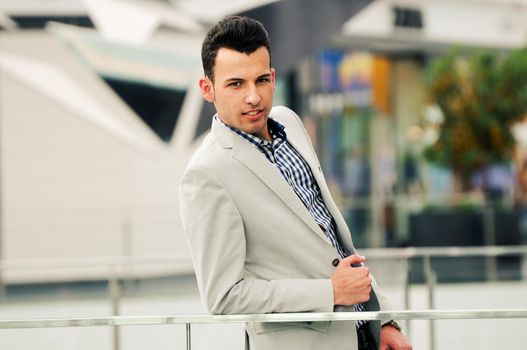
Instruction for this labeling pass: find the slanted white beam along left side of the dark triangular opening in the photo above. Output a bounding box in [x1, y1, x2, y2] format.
[0, 44, 164, 157]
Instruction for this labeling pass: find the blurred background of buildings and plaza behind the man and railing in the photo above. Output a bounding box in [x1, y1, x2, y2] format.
[0, 0, 527, 350]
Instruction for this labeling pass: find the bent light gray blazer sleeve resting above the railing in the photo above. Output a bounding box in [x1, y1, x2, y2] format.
[179, 165, 333, 314]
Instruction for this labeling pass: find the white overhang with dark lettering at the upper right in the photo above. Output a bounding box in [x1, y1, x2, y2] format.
[340, 0, 527, 51]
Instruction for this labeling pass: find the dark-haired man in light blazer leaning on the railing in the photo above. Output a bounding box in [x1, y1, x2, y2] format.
[180, 16, 411, 350]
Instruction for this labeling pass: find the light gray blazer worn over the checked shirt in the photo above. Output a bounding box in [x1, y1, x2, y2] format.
[179, 107, 389, 350]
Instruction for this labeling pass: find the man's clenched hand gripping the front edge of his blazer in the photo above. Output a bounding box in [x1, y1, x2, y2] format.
[331, 255, 371, 305]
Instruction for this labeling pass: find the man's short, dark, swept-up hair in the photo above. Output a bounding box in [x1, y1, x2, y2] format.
[201, 16, 271, 81]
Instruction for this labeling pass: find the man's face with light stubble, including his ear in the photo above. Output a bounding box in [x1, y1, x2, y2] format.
[199, 46, 275, 140]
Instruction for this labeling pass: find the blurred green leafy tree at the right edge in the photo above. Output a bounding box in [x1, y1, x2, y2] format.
[424, 48, 527, 189]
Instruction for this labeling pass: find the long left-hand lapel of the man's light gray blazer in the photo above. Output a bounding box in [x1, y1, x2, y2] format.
[212, 118, 331, 245]
